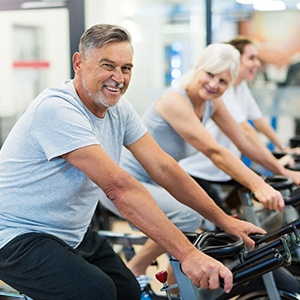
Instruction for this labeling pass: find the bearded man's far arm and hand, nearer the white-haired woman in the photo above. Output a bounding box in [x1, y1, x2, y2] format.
[128, 133, 264, 246]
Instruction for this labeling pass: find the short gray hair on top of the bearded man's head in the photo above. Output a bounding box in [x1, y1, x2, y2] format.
[79, 24, 132, 58]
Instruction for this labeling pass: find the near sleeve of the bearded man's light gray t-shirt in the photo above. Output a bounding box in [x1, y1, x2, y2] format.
[31, 97, 99, 160]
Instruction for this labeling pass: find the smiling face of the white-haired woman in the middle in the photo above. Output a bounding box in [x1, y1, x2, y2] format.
[195, 70, 231, 100]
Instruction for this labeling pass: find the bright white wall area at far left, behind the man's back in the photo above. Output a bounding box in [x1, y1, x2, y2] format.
[0, 9, 70, 117]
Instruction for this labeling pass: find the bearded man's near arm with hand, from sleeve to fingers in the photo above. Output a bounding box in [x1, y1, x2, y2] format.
[63, 145, 234, 292]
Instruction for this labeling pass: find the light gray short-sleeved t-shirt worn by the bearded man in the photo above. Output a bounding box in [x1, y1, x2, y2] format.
[0, 81, 146, 247]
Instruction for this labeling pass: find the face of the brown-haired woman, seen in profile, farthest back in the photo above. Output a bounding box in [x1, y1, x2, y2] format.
[239, 44, 261, 81]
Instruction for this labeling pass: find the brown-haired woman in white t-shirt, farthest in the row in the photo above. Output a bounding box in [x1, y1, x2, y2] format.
[180, 36, 300, 209]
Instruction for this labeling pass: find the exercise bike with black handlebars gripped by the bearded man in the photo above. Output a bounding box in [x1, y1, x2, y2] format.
[156, 220, 300, 300]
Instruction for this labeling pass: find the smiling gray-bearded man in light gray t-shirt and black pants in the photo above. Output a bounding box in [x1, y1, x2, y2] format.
[0, 24, 264, 300]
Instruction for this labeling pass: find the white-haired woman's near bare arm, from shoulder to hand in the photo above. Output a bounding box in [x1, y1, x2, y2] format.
[156, 92, 284, 210]
